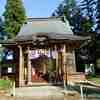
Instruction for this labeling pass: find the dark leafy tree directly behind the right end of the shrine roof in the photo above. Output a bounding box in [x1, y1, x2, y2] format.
[52, 0, 93, 35]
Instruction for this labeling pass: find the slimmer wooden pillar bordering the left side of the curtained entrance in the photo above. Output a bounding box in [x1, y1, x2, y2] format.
[27, 47, 32, 85]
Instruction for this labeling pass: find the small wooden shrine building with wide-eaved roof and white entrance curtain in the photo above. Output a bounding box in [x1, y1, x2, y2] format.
[1, 17, 89, 86]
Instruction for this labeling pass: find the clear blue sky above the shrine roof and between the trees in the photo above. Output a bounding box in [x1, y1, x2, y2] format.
[0, 0, 62, 17]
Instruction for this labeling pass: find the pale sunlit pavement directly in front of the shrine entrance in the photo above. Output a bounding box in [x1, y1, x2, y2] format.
[15, 86, 63, 96]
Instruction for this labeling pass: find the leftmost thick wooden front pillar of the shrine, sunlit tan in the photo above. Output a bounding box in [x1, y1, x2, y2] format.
[18, 45, 24, 86]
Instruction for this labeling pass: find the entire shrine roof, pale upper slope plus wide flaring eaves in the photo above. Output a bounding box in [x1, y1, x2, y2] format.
[0, 17, 90, 45]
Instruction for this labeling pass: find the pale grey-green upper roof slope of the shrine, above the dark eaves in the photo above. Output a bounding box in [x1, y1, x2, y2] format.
[18, 17, 73, 36]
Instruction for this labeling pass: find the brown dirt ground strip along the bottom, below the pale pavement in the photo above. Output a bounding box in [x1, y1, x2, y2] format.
[0, 93, 80, 100]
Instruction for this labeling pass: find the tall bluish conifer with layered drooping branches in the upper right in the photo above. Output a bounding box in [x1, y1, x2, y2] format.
[80, 0, 96, 32]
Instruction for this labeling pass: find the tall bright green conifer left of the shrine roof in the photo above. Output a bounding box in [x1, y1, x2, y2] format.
[3, 0, 26, 38]
